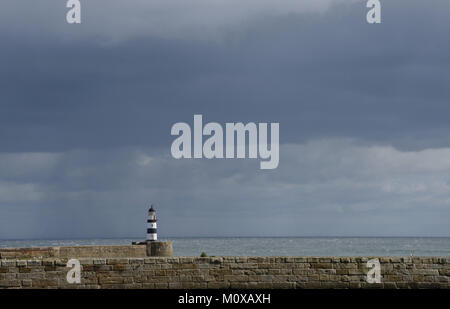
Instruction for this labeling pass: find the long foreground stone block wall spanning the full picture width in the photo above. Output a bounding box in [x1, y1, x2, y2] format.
[0, 256, 450, 289]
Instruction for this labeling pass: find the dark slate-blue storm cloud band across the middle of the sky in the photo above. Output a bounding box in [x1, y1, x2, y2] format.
[0, 1, 450, 151]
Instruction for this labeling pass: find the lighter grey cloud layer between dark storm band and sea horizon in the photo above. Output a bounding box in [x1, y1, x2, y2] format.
[0, 139, 450, 237]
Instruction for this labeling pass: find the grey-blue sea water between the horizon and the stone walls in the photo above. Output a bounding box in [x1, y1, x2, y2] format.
[0, 237, 450, 256]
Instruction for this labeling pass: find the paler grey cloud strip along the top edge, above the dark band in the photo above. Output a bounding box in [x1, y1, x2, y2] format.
[0, 0, 358, 44]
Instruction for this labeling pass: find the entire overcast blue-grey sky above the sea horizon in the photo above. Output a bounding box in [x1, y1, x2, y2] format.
[0, 0, 450, 239]
